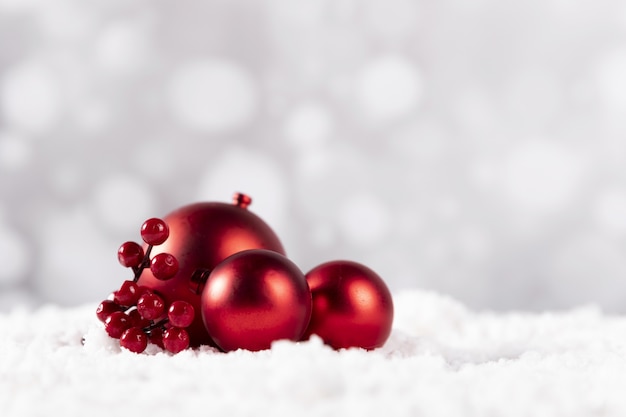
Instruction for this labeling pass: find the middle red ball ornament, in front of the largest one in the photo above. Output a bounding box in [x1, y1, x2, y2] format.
[201, 249, 311, 352]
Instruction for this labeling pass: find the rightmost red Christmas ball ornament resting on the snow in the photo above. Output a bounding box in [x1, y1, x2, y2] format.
[305, 261, 393, 350]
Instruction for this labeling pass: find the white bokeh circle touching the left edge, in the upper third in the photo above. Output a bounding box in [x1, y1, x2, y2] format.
[0, 62, 64, 133]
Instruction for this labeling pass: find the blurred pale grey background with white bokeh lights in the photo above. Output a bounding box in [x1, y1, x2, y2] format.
[0, 0, 626, 313]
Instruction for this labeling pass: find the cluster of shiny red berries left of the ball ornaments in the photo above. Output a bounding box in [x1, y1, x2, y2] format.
[96, 218, 195, 353]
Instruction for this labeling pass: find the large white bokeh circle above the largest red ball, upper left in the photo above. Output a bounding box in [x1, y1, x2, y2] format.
[169, 58, 257, 132]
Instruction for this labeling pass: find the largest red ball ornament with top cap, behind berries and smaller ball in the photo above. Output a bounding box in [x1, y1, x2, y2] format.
[137, 193, 285, 346]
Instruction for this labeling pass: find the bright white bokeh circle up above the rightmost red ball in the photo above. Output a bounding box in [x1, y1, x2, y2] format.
[355, 55, 423, 123]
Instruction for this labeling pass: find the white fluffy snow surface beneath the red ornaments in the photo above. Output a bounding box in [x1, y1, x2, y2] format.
[0, 290, 626, 417]
